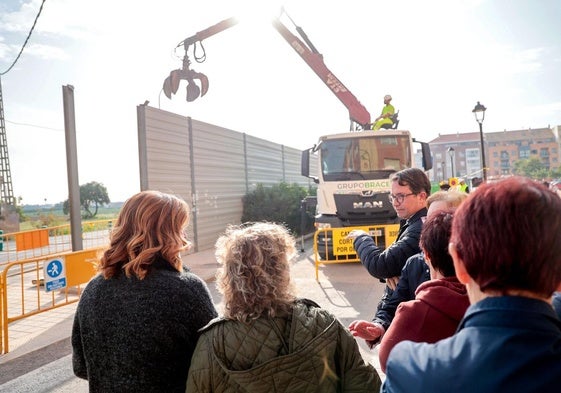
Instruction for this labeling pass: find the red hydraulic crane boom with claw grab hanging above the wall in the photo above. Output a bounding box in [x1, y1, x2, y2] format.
[163, 11, 371, 129]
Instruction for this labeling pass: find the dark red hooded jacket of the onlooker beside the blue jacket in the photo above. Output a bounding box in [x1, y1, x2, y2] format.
[378, 277, 469, 372]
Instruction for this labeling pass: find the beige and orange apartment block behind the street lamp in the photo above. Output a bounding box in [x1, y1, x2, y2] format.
[429, 126, 561, 181]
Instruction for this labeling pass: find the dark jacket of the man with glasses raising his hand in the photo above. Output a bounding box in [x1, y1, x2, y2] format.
[353, 208, 427, 279]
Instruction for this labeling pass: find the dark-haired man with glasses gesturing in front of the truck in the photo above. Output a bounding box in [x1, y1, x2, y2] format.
[348, 168, 431, 340]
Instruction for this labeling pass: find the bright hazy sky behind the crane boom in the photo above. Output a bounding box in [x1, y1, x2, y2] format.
[0, 0, 561, 204]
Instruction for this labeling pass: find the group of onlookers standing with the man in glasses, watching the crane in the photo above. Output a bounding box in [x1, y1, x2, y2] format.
[72, 169, 561, 392]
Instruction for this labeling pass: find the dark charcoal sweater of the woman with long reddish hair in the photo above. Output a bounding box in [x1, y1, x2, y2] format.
[72, 262, 217, 393]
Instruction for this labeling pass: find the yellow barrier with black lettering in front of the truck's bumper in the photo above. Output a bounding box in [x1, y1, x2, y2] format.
[314, 224, 399, 281]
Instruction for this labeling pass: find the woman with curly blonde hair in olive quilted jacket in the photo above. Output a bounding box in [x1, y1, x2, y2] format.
[187, 222, 381, 393]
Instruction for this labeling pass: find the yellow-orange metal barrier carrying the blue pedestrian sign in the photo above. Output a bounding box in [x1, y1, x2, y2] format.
[0, 247, 105, 354]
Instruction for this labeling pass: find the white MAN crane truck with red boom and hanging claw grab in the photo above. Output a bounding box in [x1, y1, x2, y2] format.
[163, 10, 432, 264]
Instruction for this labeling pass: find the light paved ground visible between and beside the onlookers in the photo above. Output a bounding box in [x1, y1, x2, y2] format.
[0, 244, 383, 393]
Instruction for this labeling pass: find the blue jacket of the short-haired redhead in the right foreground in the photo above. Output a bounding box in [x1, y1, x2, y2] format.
[382, 296, 561, 393]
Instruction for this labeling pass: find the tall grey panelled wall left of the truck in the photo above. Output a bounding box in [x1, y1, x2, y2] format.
[137, 105, 317, 252]
